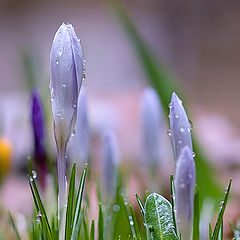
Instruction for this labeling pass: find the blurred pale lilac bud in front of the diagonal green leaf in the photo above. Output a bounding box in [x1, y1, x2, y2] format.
[140, 88, 163, 169]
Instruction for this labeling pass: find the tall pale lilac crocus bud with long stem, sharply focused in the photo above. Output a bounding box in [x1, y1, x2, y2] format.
[49, 23, 84, 240]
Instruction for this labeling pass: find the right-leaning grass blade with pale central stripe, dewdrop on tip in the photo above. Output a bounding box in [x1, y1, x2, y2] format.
[71, 164, 87, 240]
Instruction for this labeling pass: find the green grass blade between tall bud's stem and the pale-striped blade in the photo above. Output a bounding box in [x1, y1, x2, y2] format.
[65, 163, 76, 240]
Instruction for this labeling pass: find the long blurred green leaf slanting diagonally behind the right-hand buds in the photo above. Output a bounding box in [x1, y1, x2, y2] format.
[113, 4, 221, 205]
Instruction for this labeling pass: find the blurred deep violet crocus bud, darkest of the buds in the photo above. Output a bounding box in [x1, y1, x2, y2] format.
[31, 89, 47, 190]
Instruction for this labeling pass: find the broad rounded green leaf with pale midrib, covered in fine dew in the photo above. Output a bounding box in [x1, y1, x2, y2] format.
[145, 193, 179, 240]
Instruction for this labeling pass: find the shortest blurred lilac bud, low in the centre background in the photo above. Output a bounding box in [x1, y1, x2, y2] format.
[102, 130, 119, 197]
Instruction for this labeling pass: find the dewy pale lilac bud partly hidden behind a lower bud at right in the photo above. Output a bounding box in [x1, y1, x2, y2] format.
[168, 93, 192, 161]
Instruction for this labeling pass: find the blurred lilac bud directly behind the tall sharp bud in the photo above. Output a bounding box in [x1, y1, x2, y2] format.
[68, 88, 89, 163]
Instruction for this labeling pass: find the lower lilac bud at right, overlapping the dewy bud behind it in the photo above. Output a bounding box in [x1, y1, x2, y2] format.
[175, 146, 196, 240]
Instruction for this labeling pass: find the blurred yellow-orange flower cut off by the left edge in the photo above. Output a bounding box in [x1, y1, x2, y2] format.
[0, 137, 12, 178]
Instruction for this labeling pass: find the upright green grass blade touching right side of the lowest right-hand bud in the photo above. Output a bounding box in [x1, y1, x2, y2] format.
[193, 186, 200, 240]
